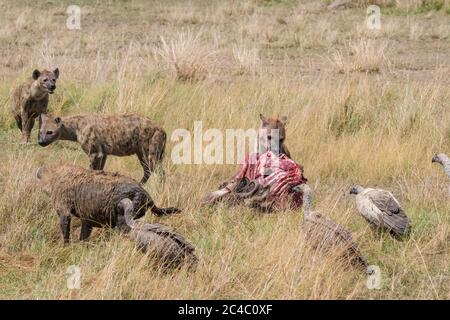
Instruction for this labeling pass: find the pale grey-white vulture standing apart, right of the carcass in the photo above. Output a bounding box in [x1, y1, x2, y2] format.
[350, 186, 410, 235]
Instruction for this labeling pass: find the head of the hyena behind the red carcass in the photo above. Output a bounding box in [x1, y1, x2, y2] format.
[258, 114, 287, 154]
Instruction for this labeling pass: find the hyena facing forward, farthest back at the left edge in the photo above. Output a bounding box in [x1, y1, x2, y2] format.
[11, 68, 59, 143]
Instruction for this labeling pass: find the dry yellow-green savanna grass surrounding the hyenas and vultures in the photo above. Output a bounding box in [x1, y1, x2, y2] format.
[0, 0, 450, 299]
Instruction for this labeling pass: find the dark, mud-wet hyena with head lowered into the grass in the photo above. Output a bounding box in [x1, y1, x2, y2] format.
[36, 164, 180, 243]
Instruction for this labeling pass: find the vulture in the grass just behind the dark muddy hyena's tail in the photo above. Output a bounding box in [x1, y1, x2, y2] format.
[121, 199, 198, 269]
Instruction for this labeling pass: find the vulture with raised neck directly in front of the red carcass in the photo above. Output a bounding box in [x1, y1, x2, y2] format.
[299, 184, 370, 273]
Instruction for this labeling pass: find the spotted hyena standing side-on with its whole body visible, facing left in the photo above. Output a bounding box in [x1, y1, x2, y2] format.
[39, 114, 166, 183]
